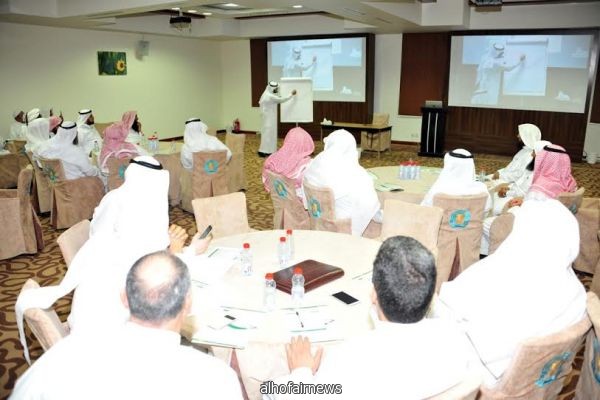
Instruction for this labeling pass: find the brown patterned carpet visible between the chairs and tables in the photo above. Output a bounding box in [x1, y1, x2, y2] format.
[0, 135, 600, 400]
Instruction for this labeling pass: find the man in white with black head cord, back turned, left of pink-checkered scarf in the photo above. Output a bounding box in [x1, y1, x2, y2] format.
[37, 121, 100, 179]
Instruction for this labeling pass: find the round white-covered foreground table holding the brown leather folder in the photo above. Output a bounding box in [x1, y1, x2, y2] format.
[186, 230, 381, 398]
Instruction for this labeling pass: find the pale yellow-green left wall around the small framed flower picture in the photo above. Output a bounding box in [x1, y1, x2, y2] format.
[0, 23, 222, 138]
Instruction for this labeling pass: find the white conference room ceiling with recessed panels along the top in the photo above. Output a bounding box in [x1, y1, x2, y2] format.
[0, 0, 600, 39]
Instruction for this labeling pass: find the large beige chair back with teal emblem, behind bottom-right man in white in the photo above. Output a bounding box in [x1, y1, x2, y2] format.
[475, 316, 591, 400]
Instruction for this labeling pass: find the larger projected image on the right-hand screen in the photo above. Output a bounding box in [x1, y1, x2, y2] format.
[448, 35, 592, 112]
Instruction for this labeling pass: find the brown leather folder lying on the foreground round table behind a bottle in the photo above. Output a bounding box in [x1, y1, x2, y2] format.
[273, 260, 344, 294]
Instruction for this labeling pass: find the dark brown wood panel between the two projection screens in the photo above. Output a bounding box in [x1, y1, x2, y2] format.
[398, 32, 450, 115]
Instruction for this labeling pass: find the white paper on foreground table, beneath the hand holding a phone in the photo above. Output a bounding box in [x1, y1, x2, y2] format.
[182, 247, 240, 285]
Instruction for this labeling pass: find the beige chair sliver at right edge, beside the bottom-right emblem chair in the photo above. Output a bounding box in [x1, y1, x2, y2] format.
[575, 292, 600, 400]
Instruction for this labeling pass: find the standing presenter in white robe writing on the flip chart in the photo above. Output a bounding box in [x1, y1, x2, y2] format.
[258, 81, 296, 157]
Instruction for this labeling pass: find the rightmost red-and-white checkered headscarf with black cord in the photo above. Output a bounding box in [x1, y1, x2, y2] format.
[529, 144, 577, 199]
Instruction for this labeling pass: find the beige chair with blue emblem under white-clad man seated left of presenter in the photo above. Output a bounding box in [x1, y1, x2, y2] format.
[181, 150, 229, 212]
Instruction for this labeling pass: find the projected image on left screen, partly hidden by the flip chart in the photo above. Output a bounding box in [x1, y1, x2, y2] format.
[268, 37, 366, 101]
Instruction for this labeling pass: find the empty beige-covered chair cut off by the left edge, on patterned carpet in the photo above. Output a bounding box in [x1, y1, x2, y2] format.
[0, 166, 44, 260]
